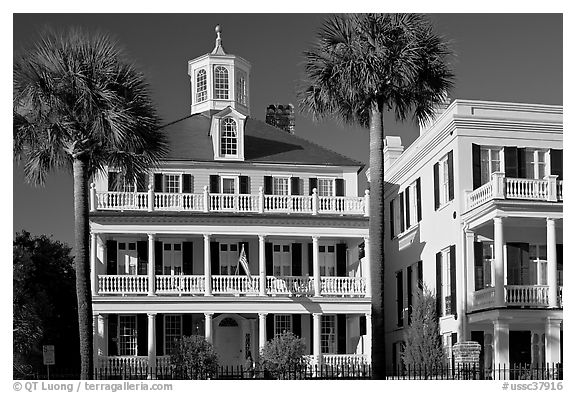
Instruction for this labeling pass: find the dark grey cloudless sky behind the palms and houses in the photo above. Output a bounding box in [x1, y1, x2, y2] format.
[13, 14, 562, 248]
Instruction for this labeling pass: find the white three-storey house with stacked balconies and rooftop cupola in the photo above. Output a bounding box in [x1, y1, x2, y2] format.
[90, 30, 371, 367]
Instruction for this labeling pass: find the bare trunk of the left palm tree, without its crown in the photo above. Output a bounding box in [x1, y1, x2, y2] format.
[73, 157, 94, 379]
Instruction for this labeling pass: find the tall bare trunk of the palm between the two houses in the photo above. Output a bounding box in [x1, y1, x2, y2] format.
[369, 96, 386, 379]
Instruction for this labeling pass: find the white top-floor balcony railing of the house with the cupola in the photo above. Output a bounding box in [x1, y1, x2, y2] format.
[90, 184, 370, 216]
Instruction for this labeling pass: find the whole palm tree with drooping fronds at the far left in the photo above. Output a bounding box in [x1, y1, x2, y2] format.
[13, 29, 166, 379]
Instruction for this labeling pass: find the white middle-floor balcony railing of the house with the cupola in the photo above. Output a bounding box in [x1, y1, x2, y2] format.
[98, 275, 366, 297]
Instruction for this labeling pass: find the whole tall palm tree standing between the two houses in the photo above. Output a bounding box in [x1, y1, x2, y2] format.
[299, 14, 454, 379]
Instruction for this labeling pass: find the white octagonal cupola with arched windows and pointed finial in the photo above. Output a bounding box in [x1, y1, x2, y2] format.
[188, 25, 250, 116]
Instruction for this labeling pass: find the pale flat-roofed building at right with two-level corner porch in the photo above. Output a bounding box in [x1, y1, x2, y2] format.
[384, 100, 563, 366]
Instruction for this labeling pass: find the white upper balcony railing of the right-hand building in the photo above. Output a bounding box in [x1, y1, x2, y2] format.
[466, 172, 564, 210]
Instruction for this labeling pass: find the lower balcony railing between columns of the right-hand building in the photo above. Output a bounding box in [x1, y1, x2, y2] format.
[472, 285, 562, 311]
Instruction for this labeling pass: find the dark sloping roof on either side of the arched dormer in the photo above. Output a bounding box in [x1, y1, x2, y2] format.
[163, 111, 363, 166]
